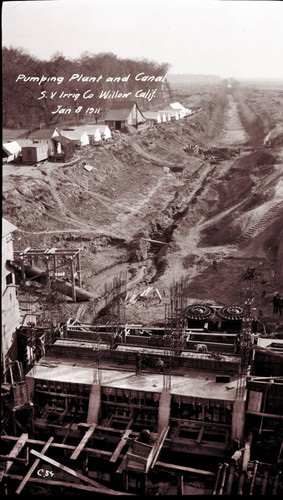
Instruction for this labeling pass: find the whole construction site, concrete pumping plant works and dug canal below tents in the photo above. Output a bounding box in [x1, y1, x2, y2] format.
[0, 83, 283, 496]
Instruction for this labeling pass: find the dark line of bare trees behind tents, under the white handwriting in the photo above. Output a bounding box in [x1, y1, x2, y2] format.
[2, 47, 171, 128]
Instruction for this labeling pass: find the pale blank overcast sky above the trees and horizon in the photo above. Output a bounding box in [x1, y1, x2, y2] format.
[2, 0, 283, 78]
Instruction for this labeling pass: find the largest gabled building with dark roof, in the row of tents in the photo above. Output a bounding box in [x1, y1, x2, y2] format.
[104, 101, 146, 130]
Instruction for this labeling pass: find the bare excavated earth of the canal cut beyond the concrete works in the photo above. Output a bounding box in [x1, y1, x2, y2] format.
[3, 90, 283, 332]
